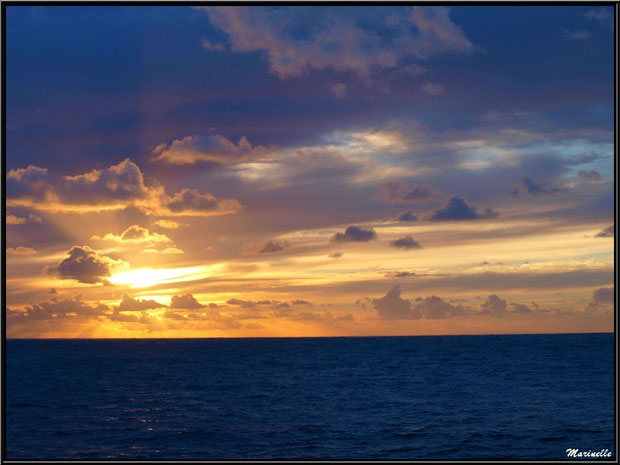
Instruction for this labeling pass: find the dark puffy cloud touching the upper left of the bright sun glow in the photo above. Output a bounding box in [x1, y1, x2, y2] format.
[44, 245, 129, 284]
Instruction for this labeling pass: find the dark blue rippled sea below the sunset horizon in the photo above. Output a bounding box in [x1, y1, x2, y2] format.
[6, 334, 614, 459]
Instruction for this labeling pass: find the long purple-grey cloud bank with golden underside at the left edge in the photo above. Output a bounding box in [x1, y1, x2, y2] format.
[7, 158, 242, 216]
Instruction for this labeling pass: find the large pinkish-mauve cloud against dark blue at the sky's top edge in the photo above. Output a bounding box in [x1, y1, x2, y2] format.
[199, 6, 473, 78]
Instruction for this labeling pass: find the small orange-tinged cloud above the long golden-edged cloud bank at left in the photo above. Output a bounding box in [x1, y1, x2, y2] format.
[153, 134, 267, 165]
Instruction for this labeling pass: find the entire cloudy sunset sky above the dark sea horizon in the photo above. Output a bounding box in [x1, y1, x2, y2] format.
[5, 4, 615, 338]
